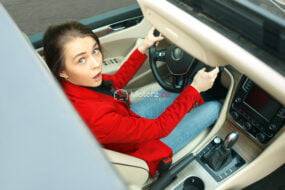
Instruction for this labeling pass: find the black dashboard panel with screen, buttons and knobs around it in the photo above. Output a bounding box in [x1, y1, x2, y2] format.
[230, 77, 285, 144]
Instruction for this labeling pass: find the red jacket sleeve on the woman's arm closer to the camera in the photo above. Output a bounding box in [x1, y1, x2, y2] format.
[89, 86, 203, 144]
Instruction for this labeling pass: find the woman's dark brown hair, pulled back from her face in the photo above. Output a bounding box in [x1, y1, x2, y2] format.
[43, 21, 101, 81]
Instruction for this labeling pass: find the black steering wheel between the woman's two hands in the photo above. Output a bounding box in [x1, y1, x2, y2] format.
[149, 45, 205, 93]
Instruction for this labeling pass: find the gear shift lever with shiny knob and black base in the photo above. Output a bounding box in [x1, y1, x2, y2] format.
[202, 132, 239, 171]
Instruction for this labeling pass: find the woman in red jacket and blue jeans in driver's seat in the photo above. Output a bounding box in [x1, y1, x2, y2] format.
[43, 22, 220, 175]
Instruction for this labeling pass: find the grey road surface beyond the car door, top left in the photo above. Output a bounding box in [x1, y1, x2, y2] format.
[1, 0, 136, 35]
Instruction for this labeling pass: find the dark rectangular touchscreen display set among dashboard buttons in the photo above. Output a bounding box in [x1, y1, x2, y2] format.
[245, 86, 280, 121]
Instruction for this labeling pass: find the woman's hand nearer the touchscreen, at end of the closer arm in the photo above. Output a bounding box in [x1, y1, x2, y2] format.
[191, 67, 219, 92]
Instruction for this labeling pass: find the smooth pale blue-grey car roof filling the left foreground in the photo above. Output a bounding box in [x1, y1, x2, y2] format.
[0, 4, 125, 190]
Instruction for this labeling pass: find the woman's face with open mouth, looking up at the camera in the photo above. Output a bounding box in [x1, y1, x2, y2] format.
[59, 36, 102, 87]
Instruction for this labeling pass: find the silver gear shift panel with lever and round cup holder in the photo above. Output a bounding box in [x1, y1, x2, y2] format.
[171, 132, 246, 190]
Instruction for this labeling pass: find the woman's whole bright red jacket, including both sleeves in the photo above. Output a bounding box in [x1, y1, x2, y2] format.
[63, 50, 203, 175]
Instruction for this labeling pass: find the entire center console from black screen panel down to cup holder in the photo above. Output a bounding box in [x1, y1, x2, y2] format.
[151, 76, 285, 190]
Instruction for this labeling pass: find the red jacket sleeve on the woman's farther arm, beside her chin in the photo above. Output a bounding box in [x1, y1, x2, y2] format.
[103, 49, 147, 89]
